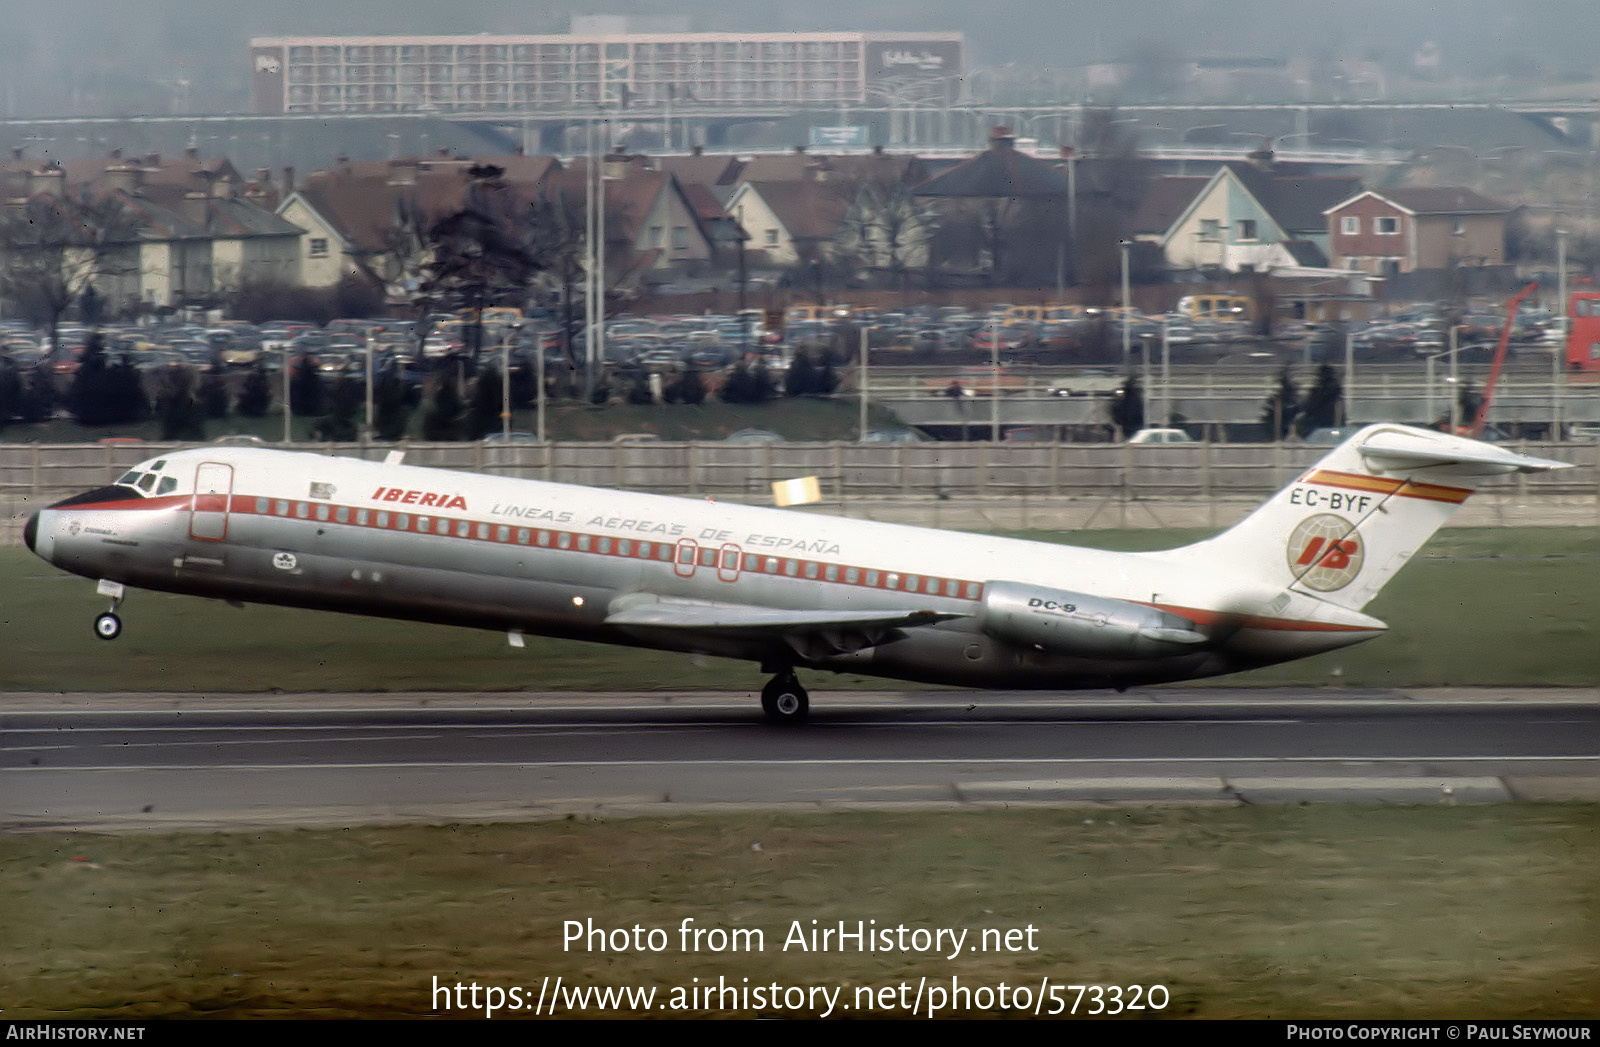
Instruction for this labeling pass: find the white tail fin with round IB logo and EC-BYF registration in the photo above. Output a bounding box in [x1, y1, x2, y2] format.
[1189, 424, 1568, 610]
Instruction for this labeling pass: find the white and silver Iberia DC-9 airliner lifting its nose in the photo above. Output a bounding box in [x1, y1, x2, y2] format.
[24, 424, 1565, 722]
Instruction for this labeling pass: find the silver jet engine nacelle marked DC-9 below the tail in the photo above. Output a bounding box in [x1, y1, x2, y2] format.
[982, 581, 1210, 658]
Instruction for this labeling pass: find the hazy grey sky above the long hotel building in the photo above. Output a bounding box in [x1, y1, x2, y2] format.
[0, 0, 1600, 115]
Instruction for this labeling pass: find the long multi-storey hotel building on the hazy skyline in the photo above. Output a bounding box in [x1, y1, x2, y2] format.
[250, 32, 963, 114]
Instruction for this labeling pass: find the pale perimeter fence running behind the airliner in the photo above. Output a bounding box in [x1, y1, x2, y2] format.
[0, 442, 1600, 544]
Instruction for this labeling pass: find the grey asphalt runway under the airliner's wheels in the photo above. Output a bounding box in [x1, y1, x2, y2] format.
[0, 688, 1600, 831]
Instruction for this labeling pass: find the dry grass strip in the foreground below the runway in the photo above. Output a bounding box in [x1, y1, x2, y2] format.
[0, 807, 1600, 1018]
